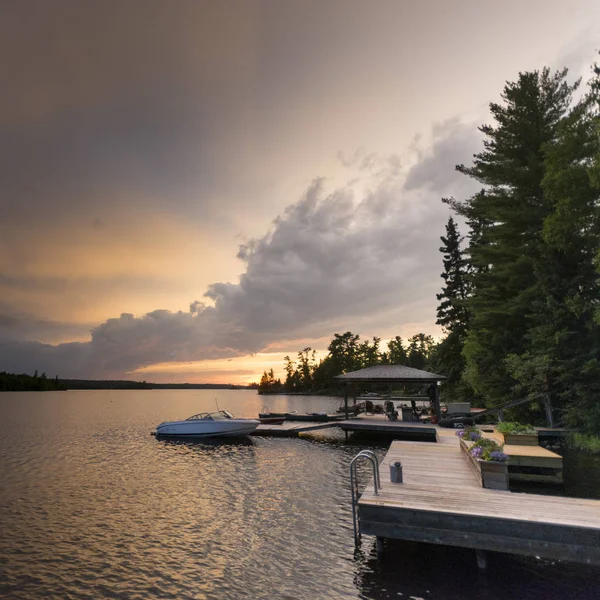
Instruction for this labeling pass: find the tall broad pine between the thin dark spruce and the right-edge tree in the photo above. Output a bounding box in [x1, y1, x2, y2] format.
[449, 69, 578, 404]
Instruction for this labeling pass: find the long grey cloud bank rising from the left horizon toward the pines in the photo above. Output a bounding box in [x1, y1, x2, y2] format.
[0, 120, 482, 377]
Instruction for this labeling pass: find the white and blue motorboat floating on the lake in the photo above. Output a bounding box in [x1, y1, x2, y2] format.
[156, 410, 260, 438]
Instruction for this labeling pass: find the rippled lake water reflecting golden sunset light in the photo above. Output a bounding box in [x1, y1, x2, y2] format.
[0, 390, 600, 600]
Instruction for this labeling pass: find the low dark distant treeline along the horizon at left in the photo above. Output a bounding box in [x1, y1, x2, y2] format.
[0, 371, 258, 392]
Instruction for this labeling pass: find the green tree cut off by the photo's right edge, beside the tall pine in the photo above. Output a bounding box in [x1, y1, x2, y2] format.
[507, 64, 600, 432]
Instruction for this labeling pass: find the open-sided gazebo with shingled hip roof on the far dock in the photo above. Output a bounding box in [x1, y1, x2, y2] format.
[334, 365, 446, 421]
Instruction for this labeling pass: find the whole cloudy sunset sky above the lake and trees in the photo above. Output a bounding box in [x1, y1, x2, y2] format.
[0, 0, 600, 383]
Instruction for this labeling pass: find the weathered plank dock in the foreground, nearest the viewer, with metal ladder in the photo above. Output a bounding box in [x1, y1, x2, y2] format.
[358, 435, 600, 564]
